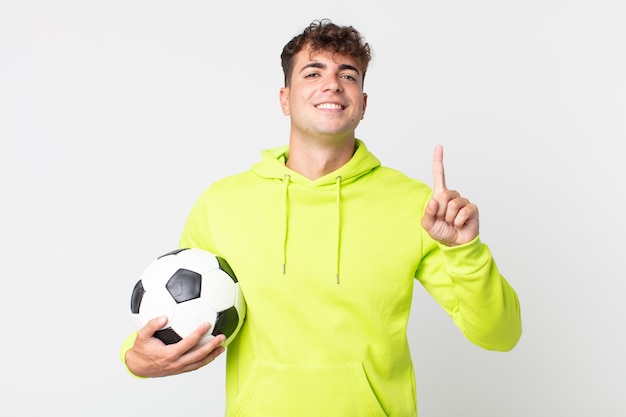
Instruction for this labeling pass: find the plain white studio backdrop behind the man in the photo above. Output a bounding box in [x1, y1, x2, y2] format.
[0, 0, 626, 417]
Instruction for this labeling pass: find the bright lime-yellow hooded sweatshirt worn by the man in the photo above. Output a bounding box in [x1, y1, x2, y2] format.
[122, 140, 521, 417]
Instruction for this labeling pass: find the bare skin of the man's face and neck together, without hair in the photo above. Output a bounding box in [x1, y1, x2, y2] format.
[280, 48, 367, 180]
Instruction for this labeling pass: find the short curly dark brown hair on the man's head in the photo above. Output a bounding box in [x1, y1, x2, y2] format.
[280, 19, 372, 87]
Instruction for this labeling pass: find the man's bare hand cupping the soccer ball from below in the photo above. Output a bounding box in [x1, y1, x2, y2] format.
[126, 316, 226, 377]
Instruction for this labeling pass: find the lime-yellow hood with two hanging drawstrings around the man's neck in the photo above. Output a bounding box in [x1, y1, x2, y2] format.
[251, 139, 380, 284]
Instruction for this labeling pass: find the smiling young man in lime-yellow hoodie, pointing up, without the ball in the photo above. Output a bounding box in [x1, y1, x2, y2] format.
[121, 20, 521, 417]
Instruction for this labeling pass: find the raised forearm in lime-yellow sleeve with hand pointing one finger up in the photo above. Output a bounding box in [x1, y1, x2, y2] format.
[417, 146, 522, 351]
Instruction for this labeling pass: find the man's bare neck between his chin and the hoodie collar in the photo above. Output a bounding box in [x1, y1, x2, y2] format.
[286, 138, 356, 180]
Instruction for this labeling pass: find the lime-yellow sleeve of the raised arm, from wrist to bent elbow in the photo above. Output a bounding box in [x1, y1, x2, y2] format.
[416, 232, 522, 352]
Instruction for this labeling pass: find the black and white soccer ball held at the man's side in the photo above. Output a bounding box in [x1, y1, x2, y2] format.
[130, 248, 246, 346]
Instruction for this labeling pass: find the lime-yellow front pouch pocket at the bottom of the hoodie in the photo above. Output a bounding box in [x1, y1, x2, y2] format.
[227, 361, 386, 417]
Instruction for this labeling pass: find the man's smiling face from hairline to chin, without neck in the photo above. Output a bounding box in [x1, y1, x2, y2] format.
[280, 48, 367, 139]
